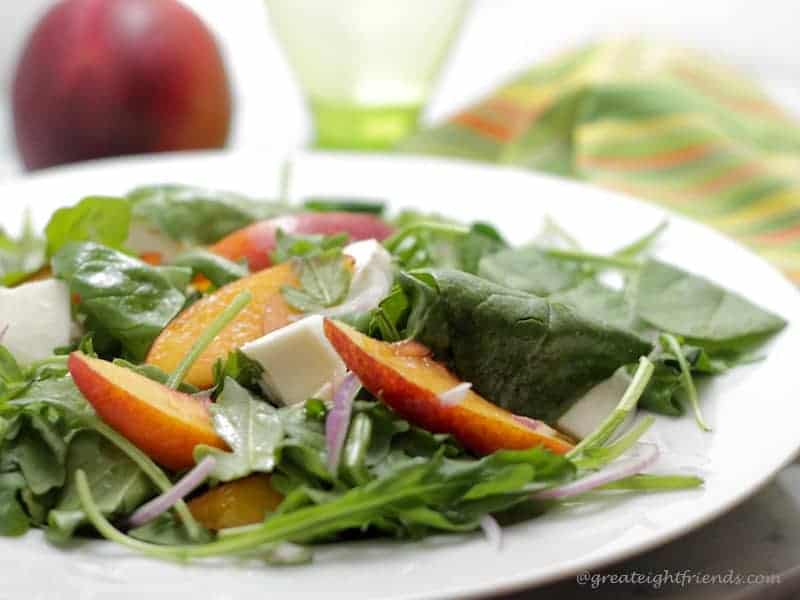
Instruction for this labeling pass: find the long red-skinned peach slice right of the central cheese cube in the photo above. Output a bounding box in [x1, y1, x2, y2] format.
[325, 319, 572, 454]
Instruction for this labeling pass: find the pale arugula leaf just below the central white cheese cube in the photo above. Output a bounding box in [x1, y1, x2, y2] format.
[195, 379, 284, 481]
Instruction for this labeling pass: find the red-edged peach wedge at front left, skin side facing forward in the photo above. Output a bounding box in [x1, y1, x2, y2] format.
[67, 352, 228, 470]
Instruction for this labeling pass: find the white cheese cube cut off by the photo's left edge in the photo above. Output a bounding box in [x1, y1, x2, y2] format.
[0, 279, 72, 364]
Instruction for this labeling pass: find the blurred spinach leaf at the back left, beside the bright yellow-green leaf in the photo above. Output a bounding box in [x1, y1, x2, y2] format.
[127, 185, 290, 244]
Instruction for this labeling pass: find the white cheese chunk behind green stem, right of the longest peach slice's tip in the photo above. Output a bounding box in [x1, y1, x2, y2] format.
[556, 369, 633, 439]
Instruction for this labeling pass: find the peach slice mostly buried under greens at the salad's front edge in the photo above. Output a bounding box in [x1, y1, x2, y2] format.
[188, 474, 283, 531]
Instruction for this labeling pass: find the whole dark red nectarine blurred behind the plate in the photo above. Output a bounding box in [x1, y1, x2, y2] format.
[13, 0, 231, 169]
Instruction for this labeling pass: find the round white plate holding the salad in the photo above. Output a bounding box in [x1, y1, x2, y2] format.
[0, 154, 800, 600]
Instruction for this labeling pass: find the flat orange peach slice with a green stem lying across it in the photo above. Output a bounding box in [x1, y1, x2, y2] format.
[146, 263, 299, 388]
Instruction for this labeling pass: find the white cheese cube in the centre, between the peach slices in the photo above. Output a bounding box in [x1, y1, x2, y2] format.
[241, 315, 346, 405]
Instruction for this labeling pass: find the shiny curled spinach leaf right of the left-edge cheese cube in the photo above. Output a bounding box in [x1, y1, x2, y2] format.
[52, 242, 190, 361]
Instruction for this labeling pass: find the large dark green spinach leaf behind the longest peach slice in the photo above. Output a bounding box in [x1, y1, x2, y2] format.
[400, 270, 652, 423]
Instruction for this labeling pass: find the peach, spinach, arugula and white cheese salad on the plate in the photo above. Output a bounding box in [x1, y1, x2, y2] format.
[0, 185, 785, 564]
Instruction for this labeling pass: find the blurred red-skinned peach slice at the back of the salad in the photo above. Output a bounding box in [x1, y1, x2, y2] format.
[209, 212, 392, 271]
